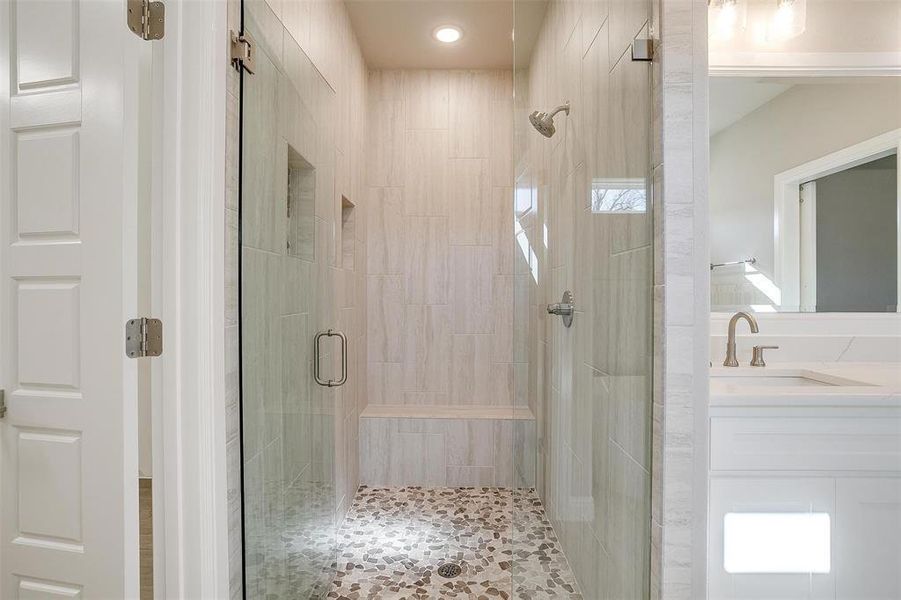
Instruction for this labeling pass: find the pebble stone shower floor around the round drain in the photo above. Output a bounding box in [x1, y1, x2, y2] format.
[327, 486, 582, 600]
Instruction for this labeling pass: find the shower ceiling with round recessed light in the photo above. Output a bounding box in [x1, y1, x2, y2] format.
[345, 0, 547, 69]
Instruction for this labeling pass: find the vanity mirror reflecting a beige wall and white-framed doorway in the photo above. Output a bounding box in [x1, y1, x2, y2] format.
[710, 77, 901, 312]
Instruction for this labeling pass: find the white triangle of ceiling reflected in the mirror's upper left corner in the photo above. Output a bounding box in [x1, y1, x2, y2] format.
[709, 77, 792, 136]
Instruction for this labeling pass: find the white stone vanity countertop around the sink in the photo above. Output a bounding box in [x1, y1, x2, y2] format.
[710, 362, 901, 408]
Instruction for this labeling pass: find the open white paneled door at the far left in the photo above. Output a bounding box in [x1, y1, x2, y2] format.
[0, 0, 144, 600]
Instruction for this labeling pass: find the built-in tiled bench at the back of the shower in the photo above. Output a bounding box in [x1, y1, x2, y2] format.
[360, 404, 536, 487]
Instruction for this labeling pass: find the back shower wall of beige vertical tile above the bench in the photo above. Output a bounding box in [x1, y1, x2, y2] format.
[366, 70, 515, 406]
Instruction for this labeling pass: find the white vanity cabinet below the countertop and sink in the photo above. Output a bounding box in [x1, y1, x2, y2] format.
[708, 404, 901, 600]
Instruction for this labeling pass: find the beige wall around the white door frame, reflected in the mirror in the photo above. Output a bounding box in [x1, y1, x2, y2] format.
[710, 78, 901, 282]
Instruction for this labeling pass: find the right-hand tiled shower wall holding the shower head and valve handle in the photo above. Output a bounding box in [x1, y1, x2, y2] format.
[516, 0, 654, 599]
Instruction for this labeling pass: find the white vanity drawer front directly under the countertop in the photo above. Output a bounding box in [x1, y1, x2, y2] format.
[710, 417, 901, 472]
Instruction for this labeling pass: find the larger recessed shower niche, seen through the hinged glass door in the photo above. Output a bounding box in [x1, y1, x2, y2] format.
[286, 145, 316, 262]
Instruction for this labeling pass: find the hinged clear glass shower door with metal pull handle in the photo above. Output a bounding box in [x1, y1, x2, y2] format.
[239, 2, 343, 599]
